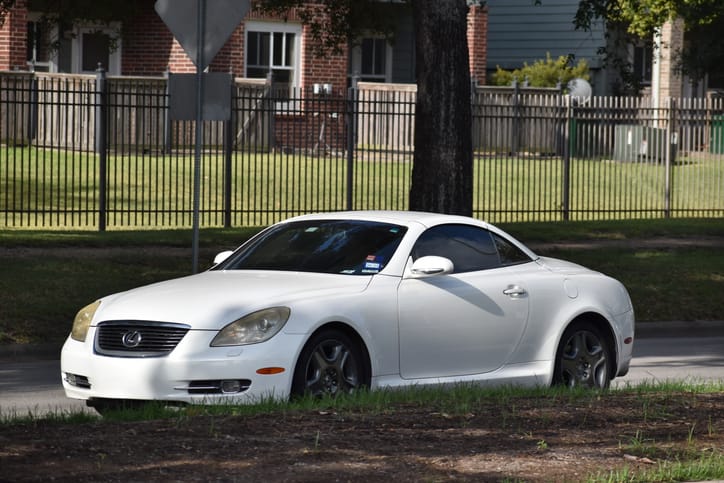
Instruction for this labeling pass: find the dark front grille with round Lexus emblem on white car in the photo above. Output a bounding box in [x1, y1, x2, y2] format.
[95, 320, 190, 357]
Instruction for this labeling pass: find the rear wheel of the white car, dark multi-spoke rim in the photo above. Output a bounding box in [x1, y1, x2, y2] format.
[553, 321, 613, 389]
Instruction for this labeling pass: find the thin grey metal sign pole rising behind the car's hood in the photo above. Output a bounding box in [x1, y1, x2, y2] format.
[191, 0, 206, 273]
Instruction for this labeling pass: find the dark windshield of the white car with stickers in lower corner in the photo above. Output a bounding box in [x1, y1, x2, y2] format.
[215, 220, 407, 275]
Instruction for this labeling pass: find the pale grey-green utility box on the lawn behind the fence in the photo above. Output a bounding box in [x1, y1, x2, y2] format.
[613, 124, 669, 163]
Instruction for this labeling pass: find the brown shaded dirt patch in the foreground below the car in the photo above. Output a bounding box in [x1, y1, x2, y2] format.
[0, 393, 724, 482]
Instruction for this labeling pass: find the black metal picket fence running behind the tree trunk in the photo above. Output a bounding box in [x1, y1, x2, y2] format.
[0, 72, 724, 229]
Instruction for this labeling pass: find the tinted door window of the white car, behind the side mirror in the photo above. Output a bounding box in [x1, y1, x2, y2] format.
[412, 225, 501, 273]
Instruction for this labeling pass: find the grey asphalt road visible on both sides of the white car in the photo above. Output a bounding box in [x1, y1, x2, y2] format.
[0, 332, 724, 418]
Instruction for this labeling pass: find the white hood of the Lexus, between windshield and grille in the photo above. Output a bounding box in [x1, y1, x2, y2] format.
[93, 270, 372, 330]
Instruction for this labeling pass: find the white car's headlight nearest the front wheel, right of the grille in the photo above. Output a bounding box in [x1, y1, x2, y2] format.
[211, 307, 291, 347]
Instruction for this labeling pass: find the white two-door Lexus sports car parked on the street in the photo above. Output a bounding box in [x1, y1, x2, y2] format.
[61, 212, 634, 412]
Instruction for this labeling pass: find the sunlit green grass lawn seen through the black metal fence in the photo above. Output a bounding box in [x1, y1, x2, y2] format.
[0, 146, 724, 229]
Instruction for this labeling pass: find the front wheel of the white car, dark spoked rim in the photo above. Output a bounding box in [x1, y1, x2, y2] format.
[292, 329, 370, 397]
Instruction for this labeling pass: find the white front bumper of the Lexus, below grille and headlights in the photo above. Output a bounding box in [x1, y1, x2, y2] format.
[60, 327, 303, 404]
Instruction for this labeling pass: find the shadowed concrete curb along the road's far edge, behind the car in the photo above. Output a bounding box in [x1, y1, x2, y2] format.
[0, 320, 724, 362]
